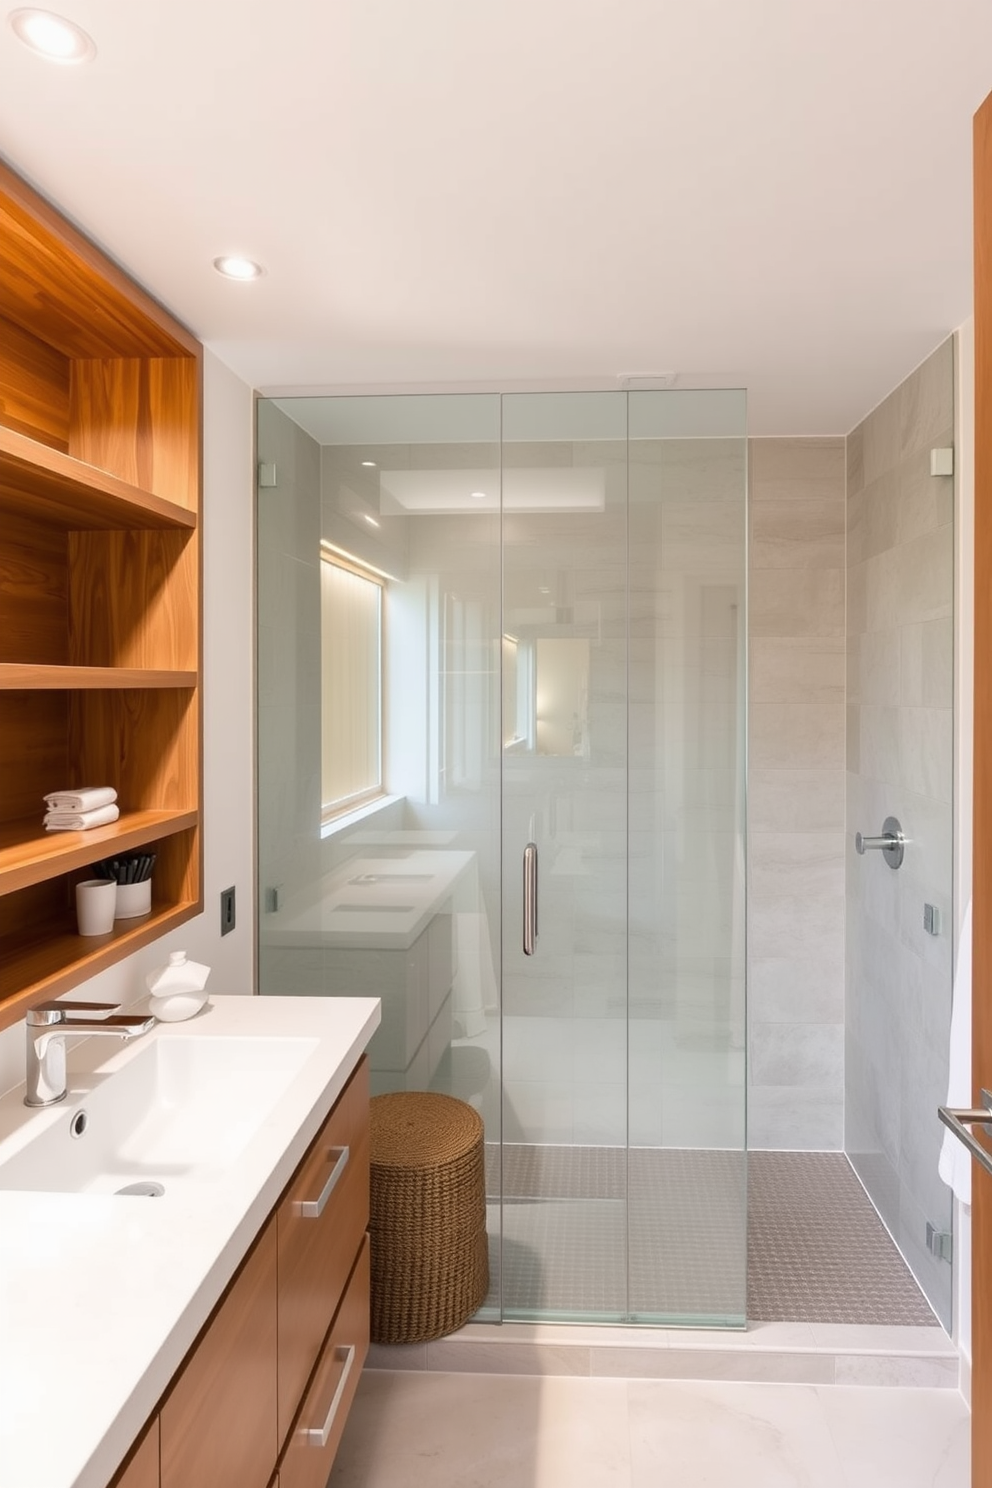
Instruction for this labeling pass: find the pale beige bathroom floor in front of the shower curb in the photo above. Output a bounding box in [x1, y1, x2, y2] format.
[329, 1370, 970, 1488]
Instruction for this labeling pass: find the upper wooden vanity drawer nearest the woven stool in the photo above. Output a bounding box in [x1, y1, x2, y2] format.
[277, 1058, 369, 1446]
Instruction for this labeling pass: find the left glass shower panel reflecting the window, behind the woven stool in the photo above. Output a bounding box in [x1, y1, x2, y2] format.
[257, 394, 501, 1308]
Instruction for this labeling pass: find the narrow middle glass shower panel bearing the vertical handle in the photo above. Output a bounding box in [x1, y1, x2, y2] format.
[503, 393, 628, 1320]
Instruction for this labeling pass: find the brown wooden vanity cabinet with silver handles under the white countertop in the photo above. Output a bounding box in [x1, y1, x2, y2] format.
[113, 1056, 369, 1488]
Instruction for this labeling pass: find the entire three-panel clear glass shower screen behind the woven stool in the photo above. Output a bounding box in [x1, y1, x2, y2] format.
[257, 390, 747, 1326]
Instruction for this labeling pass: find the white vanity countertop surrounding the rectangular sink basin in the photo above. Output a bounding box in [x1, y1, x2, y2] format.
[0, 997, 379, 1488]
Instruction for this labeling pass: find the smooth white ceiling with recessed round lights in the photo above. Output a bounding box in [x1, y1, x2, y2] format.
[0, 0, 992, 434]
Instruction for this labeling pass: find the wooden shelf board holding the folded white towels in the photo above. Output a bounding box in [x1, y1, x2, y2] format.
[0, 811, 198, 892]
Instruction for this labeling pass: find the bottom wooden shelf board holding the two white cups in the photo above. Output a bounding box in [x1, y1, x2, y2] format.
[0, 902, 199, 1024]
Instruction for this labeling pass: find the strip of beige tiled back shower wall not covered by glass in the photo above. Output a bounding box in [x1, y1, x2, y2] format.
[748, 439, 846, 1149]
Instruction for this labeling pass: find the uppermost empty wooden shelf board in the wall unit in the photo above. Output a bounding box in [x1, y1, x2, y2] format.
[0, 426, 196, 531]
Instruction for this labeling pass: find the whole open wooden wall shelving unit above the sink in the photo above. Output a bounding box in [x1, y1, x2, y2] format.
[0, 167, 202, 1027]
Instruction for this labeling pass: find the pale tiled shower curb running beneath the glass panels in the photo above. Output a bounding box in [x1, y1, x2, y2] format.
[366, 1323, 961, 1390]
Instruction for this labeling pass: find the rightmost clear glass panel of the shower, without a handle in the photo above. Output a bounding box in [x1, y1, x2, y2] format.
[628, 391, 747, 1324]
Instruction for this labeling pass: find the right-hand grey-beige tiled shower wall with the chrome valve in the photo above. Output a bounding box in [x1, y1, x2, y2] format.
[845, 338, 955, 1323]
